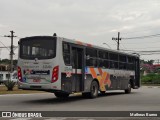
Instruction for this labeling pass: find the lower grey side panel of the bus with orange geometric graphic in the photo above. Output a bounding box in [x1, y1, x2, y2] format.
[82, 67, 135, 91]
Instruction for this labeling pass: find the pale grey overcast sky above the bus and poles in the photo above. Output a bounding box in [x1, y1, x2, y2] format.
[0, 0, 160, 60]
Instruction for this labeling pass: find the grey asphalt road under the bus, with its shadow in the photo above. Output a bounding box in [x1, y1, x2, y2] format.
[0, 87, 160, 120]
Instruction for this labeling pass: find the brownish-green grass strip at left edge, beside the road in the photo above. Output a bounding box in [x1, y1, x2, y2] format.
[0, 86, 44, 95]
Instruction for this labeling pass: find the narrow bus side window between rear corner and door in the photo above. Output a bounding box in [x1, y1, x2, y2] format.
[63, 42, 71, 65]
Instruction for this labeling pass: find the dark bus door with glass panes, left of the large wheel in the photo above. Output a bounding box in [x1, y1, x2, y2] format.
[71, 46, 85, 92]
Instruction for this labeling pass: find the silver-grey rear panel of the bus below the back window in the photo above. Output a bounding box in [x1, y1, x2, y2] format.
[18, 36, 61, 91]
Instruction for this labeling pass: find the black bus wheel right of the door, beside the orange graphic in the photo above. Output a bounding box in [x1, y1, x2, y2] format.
[89, 81, 99, 98]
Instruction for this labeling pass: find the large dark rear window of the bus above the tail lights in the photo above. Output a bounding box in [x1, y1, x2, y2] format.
[20, 37, 56, 60]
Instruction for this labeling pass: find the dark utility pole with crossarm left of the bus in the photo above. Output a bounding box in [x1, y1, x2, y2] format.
[4, 30, 17, 73]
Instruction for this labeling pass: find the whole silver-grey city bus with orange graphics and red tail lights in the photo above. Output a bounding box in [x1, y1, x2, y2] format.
[18, 36, 140, 98]
